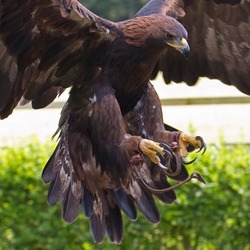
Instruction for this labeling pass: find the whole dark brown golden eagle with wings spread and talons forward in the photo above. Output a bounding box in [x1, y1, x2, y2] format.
[0, 0, 250, 243]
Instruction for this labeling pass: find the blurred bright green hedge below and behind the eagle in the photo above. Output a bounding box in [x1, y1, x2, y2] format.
[0, 138, 250, 250]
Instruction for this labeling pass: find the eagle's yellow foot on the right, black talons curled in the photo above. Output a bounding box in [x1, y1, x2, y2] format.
[179, 133, 206, 157]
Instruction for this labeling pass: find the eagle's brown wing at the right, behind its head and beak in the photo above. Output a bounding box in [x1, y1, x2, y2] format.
[138, 0, 250, 94]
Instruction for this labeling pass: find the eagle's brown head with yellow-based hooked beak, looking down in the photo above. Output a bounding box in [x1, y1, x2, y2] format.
[120, 14, 190, 57]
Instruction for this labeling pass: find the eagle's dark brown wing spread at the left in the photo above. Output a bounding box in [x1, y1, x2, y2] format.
[0, 0, 115, 119]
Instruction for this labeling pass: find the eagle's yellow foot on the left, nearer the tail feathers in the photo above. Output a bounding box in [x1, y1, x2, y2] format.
[139, 139, 174, 169]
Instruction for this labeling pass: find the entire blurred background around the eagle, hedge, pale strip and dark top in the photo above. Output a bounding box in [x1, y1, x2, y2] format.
[0, 0, 250, 250]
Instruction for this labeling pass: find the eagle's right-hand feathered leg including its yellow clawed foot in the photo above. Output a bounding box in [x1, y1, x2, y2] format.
[124, 83, 205, 157]
